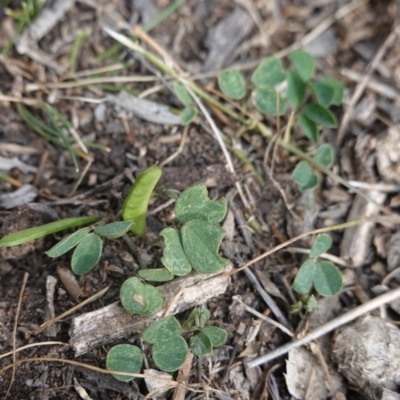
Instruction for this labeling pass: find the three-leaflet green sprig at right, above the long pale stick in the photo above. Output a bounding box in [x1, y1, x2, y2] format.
[293, 234, 343, 296]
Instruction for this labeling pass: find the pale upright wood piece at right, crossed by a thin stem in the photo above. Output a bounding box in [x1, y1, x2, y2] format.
[340, 190, 386, 268]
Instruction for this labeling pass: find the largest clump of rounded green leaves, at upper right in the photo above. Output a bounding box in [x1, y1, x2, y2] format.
[218, 51, 343, 192]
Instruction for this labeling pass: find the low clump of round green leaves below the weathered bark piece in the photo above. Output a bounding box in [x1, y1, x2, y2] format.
[107, 307, 227, 381]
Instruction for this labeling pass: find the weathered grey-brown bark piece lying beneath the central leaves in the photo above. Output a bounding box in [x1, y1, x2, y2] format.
[69, 267, 230, 356]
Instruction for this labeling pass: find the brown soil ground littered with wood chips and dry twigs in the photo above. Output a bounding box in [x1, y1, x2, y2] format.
[0, 0, 400, 400]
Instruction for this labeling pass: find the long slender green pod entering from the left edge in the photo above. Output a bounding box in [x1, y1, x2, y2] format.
[0, 217, 100, 247]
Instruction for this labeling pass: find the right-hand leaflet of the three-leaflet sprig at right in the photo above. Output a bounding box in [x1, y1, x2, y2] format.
[314, 261, 343, 296]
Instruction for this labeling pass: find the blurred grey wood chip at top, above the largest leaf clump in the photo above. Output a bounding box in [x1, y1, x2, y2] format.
[204, 8, 253, 71]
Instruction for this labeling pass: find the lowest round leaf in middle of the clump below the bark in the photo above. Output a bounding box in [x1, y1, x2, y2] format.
[152, 336, 189, 372]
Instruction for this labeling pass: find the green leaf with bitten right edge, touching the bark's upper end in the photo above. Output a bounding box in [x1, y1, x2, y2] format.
[182, 219, 229, 274]
